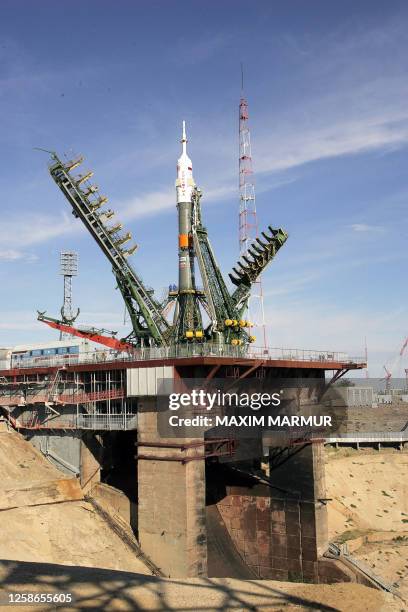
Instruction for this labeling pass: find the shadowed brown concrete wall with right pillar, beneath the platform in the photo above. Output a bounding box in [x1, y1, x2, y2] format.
[217, 443, 338, 582]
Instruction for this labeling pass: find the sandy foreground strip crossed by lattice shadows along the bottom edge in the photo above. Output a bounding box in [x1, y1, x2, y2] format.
[0, 561, 403, 612]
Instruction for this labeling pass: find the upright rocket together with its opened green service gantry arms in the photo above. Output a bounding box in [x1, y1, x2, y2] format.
[41, 122, 288, 350]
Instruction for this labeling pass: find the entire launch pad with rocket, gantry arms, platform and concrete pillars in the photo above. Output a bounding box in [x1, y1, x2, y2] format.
[0, 124, 366, 582]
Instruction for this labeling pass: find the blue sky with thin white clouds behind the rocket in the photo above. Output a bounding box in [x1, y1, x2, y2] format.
[0, 0, 408, 376]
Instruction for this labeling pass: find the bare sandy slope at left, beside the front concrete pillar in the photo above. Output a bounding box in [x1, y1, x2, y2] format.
[0, 432, 150, 574]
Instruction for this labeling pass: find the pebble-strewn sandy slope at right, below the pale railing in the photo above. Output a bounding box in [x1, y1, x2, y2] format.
[326, 449, 408, 609]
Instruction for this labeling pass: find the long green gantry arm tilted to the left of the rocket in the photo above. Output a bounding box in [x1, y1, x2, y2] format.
[49, 153, 171, 346]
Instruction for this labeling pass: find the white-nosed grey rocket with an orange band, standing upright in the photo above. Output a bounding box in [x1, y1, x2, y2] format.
[176, 121, 195, 293]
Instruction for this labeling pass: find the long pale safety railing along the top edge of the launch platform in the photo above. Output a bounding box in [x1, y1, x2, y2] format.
[0, 343, 365, 370]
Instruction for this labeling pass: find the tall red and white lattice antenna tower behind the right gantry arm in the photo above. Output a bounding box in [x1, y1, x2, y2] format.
[239, 64, 267, 348]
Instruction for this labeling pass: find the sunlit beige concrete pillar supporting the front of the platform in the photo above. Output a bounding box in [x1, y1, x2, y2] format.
[137, 397, 207, 578]
